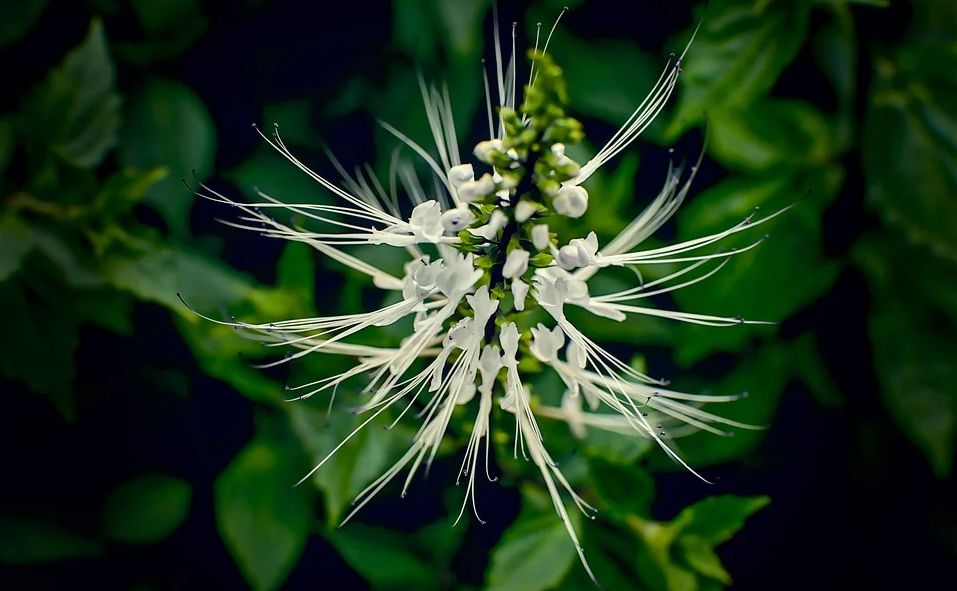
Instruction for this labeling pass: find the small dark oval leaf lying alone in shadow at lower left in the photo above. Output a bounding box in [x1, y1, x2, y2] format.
[102, 474, 192, 544]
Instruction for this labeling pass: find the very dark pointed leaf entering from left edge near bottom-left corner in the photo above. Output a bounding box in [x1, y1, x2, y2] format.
[0, 515, 103, 564]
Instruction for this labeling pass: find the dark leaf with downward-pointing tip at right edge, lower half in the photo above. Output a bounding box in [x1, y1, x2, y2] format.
[868, 292, 957, 477]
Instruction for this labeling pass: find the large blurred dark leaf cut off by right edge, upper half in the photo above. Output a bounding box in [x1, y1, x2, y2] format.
[863, 43, 957, 261]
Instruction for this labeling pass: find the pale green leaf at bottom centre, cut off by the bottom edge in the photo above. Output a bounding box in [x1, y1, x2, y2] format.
[486, 510, 581, 591]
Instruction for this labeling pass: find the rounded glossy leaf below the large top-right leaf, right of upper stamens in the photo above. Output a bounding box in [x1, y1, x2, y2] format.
[708, 99, 845, 172]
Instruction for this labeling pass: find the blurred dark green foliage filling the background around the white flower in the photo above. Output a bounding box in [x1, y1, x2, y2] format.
[0, 0, 957, 591]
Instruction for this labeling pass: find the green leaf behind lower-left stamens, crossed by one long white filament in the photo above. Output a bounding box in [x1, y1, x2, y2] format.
[290, 404, 411, 525]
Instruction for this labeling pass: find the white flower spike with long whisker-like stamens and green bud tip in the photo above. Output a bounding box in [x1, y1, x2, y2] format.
[185, 12, 773, 584]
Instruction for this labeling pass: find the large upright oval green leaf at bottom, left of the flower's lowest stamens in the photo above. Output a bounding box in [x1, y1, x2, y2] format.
[214, 424, 314, 591]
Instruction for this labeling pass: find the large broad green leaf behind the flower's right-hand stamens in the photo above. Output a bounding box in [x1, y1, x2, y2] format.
[673, 167, 843, 365]
